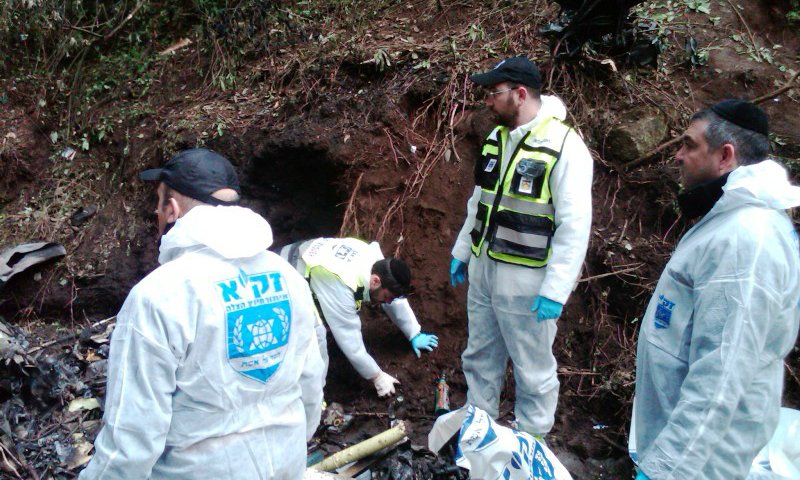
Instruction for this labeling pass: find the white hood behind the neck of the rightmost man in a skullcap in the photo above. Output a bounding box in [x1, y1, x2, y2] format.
[707, 160, 800, 218]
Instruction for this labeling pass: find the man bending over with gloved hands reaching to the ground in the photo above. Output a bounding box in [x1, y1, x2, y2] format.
[281, 238, 439, 397]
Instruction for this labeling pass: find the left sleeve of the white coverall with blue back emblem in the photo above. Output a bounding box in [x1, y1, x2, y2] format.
[80, 289, 178, 480]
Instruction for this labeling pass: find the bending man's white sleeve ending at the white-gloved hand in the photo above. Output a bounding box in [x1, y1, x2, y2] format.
[310, 267, 381, 380]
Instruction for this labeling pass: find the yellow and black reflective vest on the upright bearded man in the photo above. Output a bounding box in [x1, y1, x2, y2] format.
[471, 118, 571, 267]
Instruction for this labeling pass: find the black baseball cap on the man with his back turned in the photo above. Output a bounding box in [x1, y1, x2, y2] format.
[139, 148, 241, 205]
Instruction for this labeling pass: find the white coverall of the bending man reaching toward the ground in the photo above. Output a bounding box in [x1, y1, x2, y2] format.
[281, 238, 422, 380]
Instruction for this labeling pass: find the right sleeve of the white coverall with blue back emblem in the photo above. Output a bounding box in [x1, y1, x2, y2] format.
[298, 279, 325, 441]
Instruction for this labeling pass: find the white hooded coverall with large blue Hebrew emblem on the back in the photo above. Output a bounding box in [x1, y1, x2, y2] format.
[80, 206, 324, 480]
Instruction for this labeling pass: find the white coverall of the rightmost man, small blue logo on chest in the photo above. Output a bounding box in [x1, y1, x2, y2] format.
[633, 160, 800, 480]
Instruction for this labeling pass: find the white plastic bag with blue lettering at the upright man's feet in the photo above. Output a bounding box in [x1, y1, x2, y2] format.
[428, 405, 572, 480]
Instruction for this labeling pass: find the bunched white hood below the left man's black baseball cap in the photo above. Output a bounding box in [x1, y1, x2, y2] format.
[158, 205, 272, 265]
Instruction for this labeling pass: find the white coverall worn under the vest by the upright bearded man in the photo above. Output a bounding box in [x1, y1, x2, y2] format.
[452, 95, 592, 434]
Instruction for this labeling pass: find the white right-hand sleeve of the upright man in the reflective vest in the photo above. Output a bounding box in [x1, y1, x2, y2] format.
[539, 131, 593, 304]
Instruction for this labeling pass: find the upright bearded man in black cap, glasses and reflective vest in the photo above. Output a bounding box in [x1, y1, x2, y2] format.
[450, 57, 592, 438]
